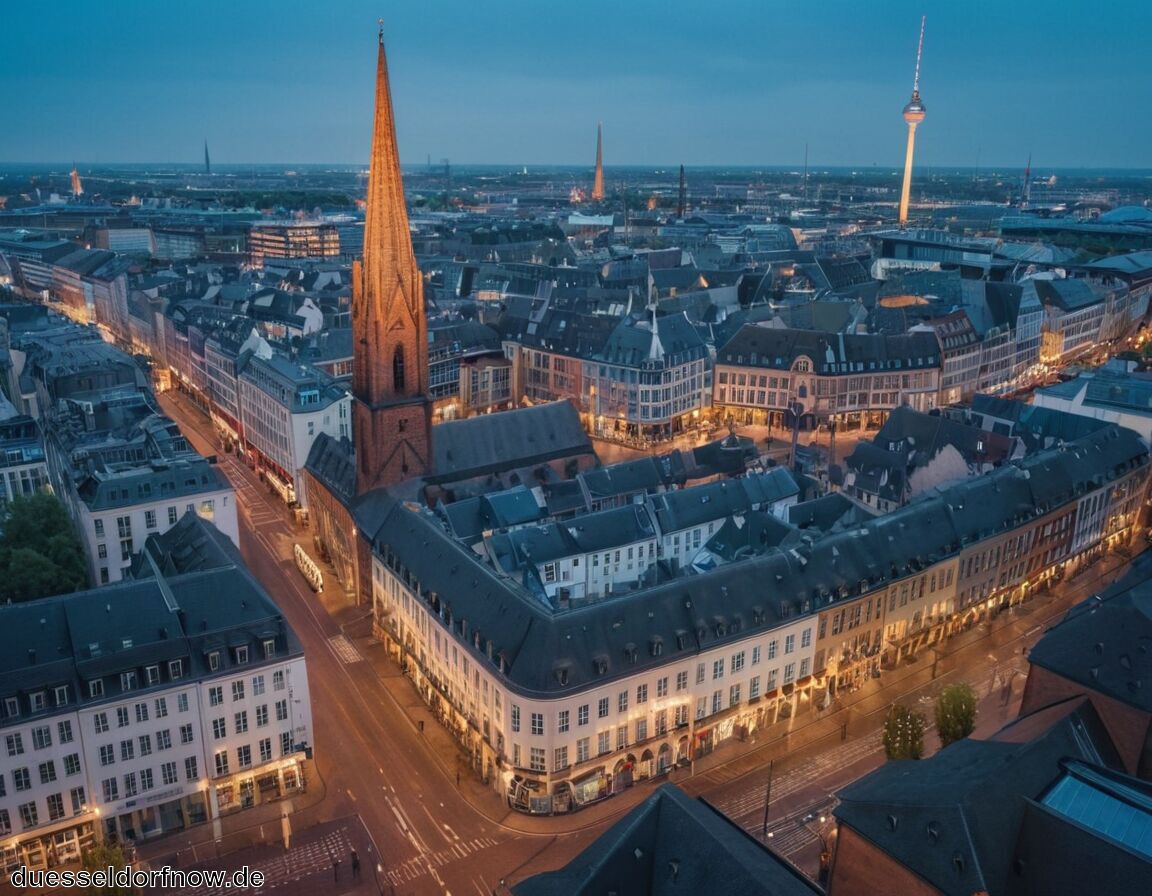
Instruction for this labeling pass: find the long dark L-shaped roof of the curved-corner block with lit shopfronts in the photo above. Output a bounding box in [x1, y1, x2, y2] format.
[354, 426, 1147, 697]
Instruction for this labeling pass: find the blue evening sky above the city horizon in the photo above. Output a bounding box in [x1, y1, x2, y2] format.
[0, 0, 1152, 172]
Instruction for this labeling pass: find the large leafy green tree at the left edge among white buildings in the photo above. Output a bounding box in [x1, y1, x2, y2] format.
[0, 493, 88, 603]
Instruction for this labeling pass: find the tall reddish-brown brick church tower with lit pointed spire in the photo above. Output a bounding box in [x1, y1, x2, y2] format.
[353, 24, 432, 494]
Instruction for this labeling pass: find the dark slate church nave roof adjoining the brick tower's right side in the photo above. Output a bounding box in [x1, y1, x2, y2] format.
[427, 401, 596, 484]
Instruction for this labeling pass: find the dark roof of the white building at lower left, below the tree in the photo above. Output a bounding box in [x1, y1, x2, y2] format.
[0, 512, 303, 723]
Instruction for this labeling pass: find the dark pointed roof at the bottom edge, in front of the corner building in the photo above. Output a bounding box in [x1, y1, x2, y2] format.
[511, 784, 821, 896]
